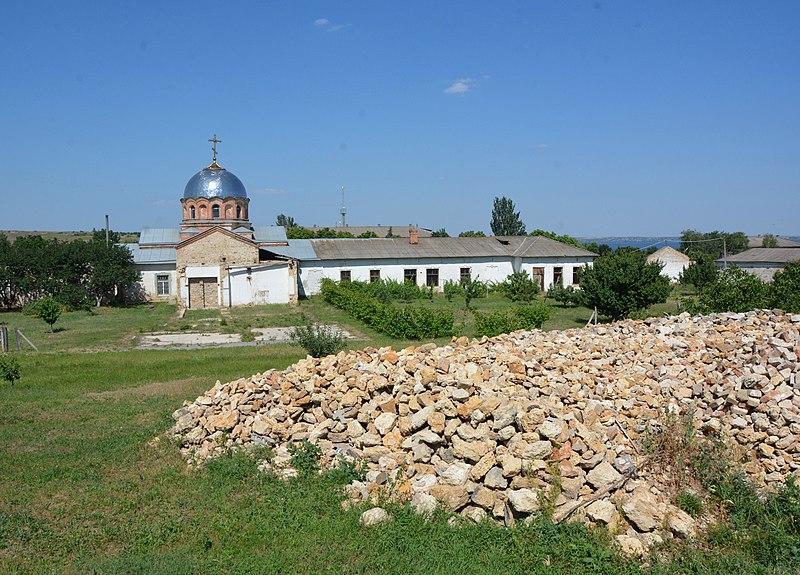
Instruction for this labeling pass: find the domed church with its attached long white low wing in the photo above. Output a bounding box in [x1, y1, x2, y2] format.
[130, 138, 596, 309]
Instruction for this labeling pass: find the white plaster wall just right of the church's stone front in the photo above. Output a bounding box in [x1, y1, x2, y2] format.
[228, 264, 294, 306]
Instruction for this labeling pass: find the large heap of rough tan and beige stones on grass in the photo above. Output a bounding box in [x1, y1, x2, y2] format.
[173, 310, 800, 551]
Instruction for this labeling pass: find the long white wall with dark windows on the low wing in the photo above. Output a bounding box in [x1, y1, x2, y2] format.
[298, 258, 591, 296]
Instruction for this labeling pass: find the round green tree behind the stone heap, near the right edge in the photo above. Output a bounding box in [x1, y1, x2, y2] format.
[698, 266, 769, 312]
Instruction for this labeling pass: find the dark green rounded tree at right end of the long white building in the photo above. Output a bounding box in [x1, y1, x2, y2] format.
[581, 250, 670, 321]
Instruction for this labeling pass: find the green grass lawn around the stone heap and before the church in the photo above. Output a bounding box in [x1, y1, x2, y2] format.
[0, 294, 796, 574]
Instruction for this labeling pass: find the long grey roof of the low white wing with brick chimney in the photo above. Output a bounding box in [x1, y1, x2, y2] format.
[310, 236, 596, 260]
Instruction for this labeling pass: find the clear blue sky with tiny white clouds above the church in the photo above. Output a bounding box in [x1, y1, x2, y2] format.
[0, 0, 800, 236]
